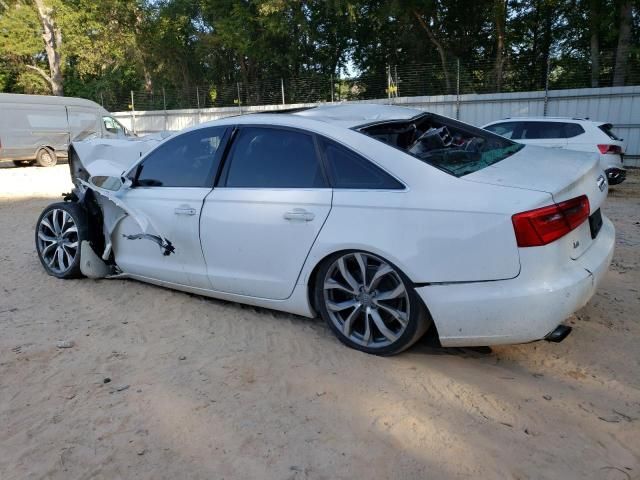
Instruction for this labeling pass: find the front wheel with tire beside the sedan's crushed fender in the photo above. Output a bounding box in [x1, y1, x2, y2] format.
[35, 202, 89, 278]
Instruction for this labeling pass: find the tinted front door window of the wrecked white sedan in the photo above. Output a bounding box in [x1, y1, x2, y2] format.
[135, 128, 226, 187]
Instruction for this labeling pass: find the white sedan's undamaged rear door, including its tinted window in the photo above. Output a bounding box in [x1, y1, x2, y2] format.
[200, 126, 332, 299]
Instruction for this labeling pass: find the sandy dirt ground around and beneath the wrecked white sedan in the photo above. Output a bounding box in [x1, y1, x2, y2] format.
[0, 165, 640, 480]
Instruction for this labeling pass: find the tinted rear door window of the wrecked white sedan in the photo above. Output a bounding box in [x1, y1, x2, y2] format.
[223, 127, 327, 188]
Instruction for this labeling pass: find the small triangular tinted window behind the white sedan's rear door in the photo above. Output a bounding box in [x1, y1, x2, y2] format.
[320, 138, 404, 190]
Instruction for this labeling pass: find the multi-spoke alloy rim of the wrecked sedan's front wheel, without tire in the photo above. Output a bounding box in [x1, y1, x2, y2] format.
[38, 208, 79, 273]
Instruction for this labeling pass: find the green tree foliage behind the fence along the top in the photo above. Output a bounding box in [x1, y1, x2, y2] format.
[0, 0, 640, 103]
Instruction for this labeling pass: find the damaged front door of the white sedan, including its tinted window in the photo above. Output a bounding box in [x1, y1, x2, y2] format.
[112, 127, 226, 289]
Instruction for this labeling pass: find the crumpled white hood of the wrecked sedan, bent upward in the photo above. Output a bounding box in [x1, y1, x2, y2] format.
[72, 132, 172, 176]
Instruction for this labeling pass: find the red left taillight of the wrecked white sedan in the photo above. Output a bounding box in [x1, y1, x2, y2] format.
[511, 195, 589, 247]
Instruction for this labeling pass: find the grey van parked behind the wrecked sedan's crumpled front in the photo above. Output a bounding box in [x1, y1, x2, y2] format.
[0, 93, 135, 167]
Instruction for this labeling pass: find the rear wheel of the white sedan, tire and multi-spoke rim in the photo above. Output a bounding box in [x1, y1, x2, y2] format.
[313, 251, 432, 356]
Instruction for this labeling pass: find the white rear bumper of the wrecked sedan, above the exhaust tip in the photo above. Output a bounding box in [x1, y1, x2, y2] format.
[416, 217, 615, 346]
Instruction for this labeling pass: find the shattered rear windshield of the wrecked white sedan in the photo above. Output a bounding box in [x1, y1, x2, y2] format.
[358, 113, 524, 177]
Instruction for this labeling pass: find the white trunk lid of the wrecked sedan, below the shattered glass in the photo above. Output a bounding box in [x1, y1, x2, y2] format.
[462, 145, 608, 259]
